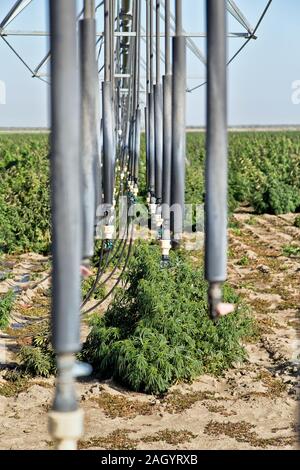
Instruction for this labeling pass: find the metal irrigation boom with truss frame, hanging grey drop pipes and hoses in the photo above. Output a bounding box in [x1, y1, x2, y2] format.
[0, 0, 271, 449]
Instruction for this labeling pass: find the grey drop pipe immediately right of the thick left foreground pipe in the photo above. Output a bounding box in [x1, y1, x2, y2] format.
[79, 0, 99, 265]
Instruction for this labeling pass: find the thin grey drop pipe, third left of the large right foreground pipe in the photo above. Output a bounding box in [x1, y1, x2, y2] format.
[153, 0, 163, 205]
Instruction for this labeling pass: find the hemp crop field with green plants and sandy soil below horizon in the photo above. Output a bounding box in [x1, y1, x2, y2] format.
[0, 131, 300, 449]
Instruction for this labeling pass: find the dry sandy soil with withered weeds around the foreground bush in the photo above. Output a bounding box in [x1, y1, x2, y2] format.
[0, 211, 300, 450]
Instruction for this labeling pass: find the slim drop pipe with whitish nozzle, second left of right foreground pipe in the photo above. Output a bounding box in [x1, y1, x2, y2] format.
[161, 0, 172, 261]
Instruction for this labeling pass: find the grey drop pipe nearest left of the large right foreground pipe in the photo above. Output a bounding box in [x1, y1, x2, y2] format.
[171, 0, 186, 248]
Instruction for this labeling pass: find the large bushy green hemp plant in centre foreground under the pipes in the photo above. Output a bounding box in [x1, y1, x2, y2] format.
[81, 243, 253, 394]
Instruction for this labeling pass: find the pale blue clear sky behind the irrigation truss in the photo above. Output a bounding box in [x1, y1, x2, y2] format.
[0, 0, 300, 127]
